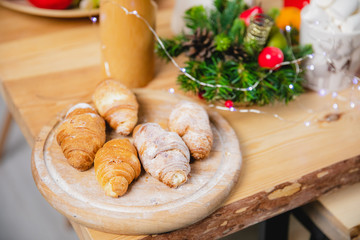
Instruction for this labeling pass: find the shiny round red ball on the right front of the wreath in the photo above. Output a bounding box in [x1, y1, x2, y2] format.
[258, 47, 284, 68]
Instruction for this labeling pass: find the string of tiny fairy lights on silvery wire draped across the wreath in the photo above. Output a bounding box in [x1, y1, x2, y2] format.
[90, 0, 360, 127]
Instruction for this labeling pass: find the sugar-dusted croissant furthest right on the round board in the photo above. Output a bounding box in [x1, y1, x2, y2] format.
[168, 101, 213, 159]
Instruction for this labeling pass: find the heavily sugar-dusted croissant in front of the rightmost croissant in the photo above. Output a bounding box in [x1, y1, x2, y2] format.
[133, 123, 190, 187]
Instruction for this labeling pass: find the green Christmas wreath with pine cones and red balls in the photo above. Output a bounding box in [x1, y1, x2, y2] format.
[156, 0, 312, 107]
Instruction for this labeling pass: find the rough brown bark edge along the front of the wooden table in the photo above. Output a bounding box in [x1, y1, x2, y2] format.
[80, 157, 360, 240]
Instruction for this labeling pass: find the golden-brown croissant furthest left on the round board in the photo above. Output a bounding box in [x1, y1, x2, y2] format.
[56, 103, 106, 171]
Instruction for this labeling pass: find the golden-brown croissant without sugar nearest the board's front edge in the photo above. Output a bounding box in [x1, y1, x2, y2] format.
[94, 139, 141, 197]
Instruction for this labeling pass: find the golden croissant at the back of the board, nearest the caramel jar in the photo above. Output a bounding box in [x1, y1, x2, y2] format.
[92, 79, 139, 135]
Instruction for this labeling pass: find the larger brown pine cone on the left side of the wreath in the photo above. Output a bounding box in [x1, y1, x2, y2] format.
[183, 28, 215, 60]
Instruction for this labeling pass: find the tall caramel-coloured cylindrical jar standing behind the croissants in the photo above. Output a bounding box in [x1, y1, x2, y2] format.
[100, 0, 156, 88]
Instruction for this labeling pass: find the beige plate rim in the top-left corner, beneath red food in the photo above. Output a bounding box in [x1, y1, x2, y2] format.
[0, 0, 99, 18]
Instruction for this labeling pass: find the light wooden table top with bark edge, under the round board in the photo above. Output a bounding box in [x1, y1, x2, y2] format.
[0, 0, 360, 239]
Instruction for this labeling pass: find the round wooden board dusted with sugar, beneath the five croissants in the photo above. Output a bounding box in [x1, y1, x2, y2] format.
[32, 89, 242, 234]
